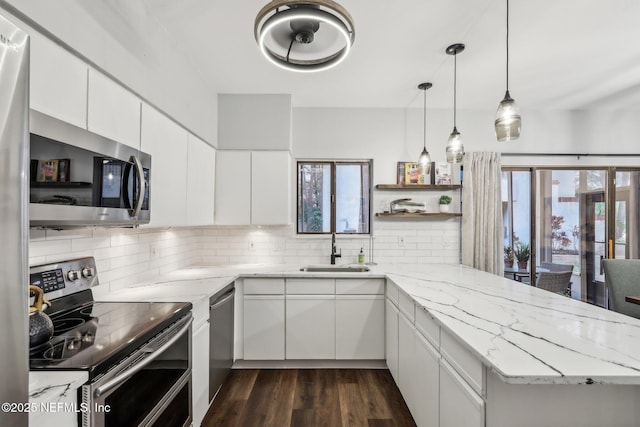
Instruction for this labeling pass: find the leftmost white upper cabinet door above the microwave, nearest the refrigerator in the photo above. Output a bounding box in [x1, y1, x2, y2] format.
[29, 32, 88, 129]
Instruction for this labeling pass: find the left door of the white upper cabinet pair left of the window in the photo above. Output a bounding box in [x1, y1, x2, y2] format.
[215, 150, 251, 225]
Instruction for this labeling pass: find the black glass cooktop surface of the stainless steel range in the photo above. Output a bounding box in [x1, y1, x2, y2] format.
[29, 292, 191, 378]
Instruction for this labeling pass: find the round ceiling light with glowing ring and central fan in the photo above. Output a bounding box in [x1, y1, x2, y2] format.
[254, 0, 355, 72]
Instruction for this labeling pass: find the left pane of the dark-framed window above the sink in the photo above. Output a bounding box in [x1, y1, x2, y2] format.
[298, 163, 331, 233]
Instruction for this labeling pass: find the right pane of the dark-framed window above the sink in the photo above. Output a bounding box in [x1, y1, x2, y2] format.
[336, 163, 369, 233]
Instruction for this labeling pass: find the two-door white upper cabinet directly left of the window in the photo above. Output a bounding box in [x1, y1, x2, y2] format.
[215, 150, 291, 225]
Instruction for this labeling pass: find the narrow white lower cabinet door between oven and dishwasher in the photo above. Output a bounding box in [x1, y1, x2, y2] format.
[191, 321, 209, 425]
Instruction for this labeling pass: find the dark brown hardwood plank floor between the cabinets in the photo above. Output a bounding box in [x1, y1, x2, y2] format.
[202, 369, 415, 427]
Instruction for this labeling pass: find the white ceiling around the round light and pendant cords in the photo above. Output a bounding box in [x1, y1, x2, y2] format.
[91, 0, 640, 109]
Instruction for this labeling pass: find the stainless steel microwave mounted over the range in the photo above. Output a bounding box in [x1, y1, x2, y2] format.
[29, 110, 151, 229]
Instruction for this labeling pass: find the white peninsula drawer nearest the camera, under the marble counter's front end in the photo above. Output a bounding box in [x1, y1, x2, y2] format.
[440, 330, 485, 395]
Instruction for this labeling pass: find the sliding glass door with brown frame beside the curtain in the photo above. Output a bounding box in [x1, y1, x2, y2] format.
[502, 168, 640, 307]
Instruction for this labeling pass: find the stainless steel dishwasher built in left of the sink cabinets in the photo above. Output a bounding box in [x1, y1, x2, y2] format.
[209, 283, 235, 403]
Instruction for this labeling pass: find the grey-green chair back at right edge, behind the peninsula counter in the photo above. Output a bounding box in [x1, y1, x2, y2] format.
[602, 259, 640, 318]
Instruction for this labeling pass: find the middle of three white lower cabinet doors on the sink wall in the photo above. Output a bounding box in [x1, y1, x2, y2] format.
[286, 295, 336, 359]
